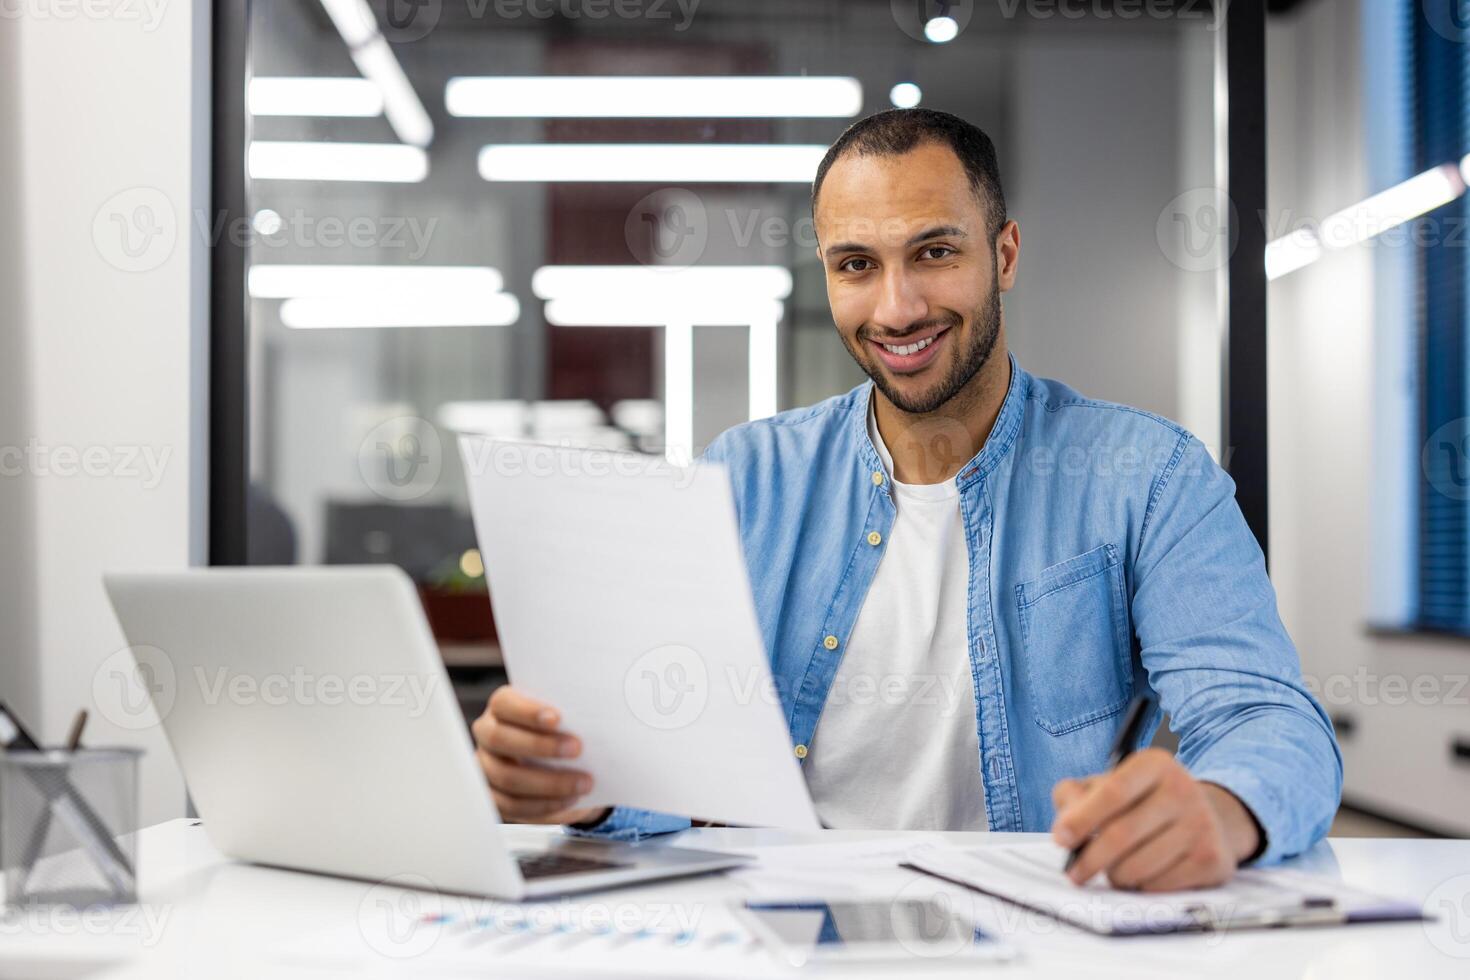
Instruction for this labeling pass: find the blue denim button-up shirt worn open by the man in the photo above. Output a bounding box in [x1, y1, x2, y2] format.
[573, 357, 1342, 862]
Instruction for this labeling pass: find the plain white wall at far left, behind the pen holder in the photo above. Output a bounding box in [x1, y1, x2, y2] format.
[0, 0, 209, 823]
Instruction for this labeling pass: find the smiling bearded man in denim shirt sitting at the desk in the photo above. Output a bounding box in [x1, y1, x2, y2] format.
[475, 109, 1342, 890]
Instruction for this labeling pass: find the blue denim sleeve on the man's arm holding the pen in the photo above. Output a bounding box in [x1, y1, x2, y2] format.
[1132, 435, 1342, 864]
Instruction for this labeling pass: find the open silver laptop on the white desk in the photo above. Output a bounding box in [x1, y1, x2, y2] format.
[103, 566, 748, 899]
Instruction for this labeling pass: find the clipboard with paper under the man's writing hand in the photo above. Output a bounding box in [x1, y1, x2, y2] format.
[907, 843, 1423, 936]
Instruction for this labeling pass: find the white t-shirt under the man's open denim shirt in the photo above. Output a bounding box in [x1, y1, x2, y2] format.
[803, 401, 988, 830]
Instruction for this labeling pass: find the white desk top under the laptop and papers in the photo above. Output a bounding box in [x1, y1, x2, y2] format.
[0, 820, 1470, 980]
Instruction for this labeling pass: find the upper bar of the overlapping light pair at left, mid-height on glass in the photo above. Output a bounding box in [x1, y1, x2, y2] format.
[250, 264, 504, 300]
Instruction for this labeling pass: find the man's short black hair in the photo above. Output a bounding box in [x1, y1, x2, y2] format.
[811, 109, 1005, 239]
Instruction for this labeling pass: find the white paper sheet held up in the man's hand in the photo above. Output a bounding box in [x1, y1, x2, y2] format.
[460, 435, 820, 829]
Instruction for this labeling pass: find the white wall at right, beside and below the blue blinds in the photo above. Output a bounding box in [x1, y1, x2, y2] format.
[1267, 0, 1470, 833]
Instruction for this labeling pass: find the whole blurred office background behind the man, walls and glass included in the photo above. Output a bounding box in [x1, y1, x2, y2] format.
[0, 0, 1470, 833]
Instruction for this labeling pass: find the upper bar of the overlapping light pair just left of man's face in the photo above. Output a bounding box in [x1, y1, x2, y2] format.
[531, 266, 791, 306]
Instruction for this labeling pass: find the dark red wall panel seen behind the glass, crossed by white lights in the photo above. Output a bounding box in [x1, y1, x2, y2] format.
[544, 40, 773, 410]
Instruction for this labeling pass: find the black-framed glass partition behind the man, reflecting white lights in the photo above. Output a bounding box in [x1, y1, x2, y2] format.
[245, 0, 1226, 705]
